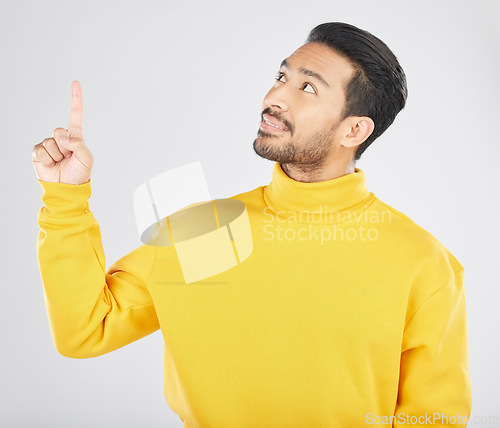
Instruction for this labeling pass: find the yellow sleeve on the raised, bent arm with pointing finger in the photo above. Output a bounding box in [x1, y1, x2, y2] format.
[37, 181, 159, 358]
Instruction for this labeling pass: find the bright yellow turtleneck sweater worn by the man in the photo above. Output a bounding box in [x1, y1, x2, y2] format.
[38, 163, 471, 428]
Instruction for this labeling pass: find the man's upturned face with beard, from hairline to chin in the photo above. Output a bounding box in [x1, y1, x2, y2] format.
[253, 43, 354, 166]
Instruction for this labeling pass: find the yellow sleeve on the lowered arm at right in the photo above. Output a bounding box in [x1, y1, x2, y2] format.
[394, 268, 471, 427]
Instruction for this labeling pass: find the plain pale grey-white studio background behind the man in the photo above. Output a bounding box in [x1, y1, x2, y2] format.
[0, 0, 500, 428]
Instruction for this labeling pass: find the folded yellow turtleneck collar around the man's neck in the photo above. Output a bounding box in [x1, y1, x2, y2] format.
[264, 162, 375, 223]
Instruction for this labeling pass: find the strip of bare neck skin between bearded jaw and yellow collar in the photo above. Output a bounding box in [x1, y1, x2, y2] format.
[280, 161, 355, 183]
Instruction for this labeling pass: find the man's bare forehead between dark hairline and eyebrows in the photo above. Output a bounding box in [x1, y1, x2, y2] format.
[286, 43, 355, 87]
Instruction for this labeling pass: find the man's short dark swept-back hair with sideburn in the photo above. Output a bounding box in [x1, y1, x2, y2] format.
[307, 22, 408, 160]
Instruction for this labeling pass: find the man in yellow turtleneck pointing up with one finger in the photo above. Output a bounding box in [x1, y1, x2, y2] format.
[33, 23, 471, 428]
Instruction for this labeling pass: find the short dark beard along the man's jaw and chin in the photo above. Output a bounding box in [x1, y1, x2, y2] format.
[253, 123, 339, 172]
